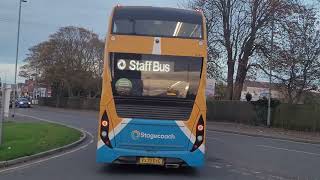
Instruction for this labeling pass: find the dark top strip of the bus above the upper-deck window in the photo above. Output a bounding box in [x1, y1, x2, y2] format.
[114, 6, 203, 24]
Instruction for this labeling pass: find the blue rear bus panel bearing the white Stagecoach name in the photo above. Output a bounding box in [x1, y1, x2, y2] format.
[115, 119, 189, 151]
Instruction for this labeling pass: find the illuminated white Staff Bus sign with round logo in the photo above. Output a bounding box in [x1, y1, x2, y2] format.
[117, 59, 174, 73]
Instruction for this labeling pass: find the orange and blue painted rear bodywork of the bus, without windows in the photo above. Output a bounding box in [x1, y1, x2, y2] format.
[96, 6, 207, 167]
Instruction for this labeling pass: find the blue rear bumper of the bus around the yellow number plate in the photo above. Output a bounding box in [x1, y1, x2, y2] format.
[96, 145, 204, 167]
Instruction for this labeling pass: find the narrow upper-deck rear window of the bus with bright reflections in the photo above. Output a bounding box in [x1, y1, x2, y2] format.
[113, 19, 203, 39]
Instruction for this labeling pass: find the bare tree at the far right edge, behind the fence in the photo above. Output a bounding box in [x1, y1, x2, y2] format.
[260, 7, 320, 103]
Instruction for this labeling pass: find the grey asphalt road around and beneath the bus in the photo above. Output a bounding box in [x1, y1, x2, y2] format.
[0, 107, 320, 180]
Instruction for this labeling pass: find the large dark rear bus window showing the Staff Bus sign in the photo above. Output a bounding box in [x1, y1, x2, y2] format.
[110, 53, 203, 100]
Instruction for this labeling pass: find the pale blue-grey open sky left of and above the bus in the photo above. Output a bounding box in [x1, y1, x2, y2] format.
[0, 0, 182, 83]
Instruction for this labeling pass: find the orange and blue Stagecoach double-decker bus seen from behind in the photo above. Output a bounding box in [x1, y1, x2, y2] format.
[96, 6, 207, 167]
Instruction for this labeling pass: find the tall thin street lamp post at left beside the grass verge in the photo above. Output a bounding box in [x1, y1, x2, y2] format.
[12, 0, 27, 118]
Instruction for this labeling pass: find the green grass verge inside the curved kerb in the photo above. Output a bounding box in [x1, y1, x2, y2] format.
[0, 122, 81, 161]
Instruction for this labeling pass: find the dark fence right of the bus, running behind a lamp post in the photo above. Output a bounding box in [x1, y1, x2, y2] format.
[207, 101, 320, 131]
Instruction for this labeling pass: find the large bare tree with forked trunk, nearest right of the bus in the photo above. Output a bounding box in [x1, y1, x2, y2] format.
[188, 0, 295, 100]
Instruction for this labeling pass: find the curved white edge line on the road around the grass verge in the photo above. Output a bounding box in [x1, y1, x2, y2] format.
[0, 113, 94, 173]
